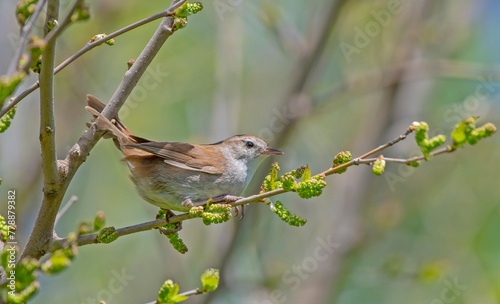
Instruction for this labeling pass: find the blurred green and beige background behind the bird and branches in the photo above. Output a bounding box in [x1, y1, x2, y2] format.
[0, 0, 500, 304]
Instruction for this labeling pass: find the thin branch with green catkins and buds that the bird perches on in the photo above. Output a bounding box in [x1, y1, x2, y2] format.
[43, 117, 496, 253]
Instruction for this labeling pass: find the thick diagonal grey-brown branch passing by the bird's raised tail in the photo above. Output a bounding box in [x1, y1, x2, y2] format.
[21, 0, 186, 258]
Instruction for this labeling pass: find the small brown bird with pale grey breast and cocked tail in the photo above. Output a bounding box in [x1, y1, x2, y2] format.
[85, 95, 284, 212]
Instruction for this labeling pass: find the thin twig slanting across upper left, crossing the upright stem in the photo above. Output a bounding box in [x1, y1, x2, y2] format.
[0, 0, 187, 117]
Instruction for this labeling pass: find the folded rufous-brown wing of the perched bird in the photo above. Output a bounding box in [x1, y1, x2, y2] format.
[126, 141, 225, 175]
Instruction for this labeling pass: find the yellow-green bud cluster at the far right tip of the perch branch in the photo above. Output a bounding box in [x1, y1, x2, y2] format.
[451, 116, 496, 149]
